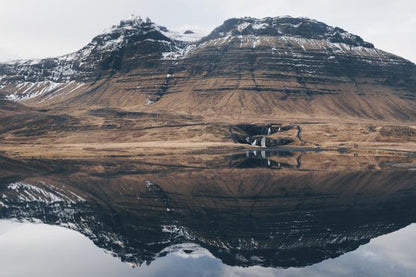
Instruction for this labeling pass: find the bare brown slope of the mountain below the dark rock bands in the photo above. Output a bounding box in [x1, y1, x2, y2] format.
[17, 71, 416, 122]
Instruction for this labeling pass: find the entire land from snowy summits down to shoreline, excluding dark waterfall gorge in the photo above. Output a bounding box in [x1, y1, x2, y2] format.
[0, 17, 416, 155]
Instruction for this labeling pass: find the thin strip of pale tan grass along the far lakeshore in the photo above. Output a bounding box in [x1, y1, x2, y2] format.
[0, 141, 416, 159]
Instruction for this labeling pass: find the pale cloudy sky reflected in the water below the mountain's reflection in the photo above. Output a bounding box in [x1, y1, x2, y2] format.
[0, 220, 416, 276]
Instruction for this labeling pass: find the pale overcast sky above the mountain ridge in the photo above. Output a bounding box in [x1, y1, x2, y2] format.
[0, 0, 416, 62]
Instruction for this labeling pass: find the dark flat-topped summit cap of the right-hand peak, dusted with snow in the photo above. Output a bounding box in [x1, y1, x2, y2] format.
[204, 16, 374, 48]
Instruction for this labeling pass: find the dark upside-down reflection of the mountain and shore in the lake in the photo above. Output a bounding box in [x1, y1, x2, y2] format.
[0, 151, 416, 267]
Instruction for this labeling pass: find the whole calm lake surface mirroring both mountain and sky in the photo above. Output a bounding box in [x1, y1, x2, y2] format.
[0, 151, 416, 276]
